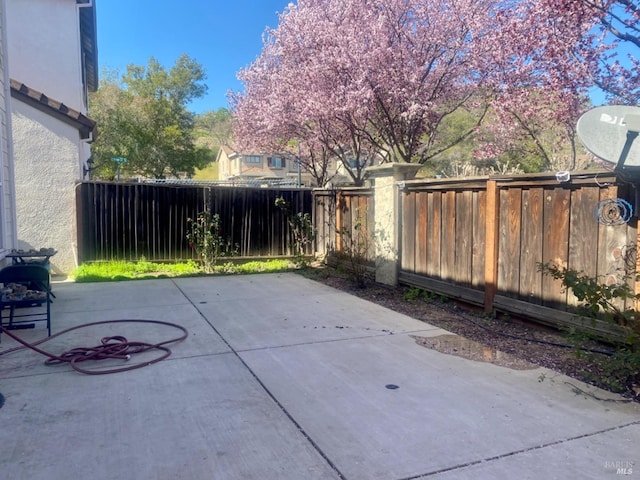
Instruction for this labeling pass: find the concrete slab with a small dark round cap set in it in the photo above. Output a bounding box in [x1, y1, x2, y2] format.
[241, 335, 639, 479]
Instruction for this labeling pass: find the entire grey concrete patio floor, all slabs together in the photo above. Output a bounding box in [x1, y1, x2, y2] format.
[0, 274, 640, 480]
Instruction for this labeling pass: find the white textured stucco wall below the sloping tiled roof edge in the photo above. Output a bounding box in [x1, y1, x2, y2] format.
[11, 99, 79, 274]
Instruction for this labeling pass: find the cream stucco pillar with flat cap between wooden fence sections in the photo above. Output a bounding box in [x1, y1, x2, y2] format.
[367, 163, 422, 286]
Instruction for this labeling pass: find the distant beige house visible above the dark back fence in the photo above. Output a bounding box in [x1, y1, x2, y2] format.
[216, 145, 310, 185]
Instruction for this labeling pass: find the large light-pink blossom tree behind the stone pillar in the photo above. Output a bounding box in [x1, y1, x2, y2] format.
[232, 0, 495, 182]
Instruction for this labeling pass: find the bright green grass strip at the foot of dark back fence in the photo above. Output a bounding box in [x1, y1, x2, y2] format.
[71, 259, 294, 283]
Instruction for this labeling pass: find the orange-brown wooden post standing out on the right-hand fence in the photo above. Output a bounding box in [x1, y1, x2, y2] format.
[484, 180, 500, 312]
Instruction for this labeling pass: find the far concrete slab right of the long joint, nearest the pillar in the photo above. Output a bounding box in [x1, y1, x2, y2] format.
[176, 274, 447, 351]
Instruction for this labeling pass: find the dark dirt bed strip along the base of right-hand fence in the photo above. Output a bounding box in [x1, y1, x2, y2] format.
[304, 266, 640, 401]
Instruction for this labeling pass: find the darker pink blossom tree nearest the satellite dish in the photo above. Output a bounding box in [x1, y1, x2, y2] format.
[478, 0, 640, 169]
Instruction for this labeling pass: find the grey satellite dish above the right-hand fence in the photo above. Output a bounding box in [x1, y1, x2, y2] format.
[578, 105, 640, 170]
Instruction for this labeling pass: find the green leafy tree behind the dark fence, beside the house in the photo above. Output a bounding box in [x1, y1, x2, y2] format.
[89, 54, 211, 179]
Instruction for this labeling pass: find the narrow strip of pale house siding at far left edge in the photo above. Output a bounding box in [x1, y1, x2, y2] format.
[0, 0, 17, 264]
